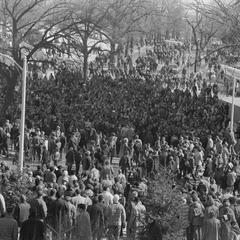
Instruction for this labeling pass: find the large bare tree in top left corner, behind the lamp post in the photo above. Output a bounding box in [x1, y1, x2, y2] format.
[0, 0, 74, 112]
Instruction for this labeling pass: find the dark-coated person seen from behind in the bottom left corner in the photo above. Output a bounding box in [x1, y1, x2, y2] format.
[0, 205, 18, 240]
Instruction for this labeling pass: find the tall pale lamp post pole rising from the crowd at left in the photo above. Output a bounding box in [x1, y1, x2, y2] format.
[19, 56, 27, 173]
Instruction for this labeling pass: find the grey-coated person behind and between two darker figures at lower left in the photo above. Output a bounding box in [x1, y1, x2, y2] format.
[13, 194, 30, 227]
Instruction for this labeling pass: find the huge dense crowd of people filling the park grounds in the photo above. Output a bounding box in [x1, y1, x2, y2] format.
[0, 39, 240, 240]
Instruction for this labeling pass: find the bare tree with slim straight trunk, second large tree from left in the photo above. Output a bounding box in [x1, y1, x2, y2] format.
[68, 0, 108, 81]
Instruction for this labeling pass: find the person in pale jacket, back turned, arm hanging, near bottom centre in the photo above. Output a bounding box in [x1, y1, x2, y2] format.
[109, 194, 126, 240]
